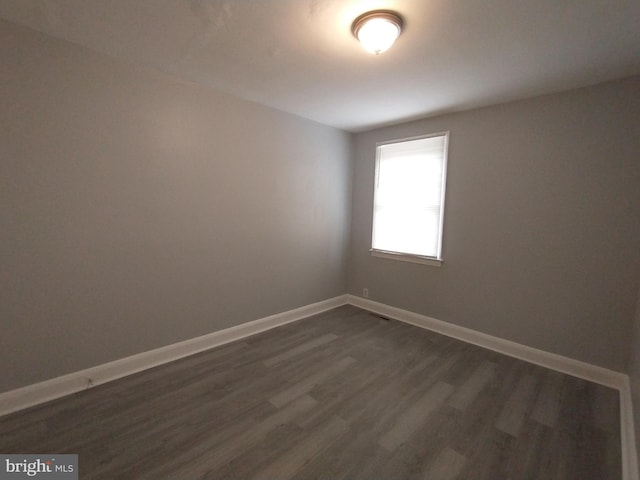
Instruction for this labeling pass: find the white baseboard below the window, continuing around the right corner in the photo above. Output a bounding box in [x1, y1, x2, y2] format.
[347, 295, 639, 480]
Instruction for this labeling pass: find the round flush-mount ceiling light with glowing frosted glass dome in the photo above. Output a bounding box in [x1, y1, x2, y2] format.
[351, 10, 404, 55]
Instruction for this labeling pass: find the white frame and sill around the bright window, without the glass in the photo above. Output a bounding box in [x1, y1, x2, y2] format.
[370, 131, 449, 267]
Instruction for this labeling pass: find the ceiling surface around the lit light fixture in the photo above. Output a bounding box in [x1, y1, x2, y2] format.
[0, 0, 640, 131]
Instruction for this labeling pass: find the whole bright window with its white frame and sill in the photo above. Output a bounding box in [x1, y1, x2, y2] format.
[371, 132, 449, 265]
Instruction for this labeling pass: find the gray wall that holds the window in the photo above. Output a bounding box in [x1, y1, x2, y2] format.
[348, 77, 640, 371]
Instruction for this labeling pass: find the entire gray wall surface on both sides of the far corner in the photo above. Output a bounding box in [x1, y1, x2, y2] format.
[0, 15, 640, 398]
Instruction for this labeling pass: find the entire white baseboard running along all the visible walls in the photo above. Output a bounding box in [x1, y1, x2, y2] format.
[0, 295, 640, 480]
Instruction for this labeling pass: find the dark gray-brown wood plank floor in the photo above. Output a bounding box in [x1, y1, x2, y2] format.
[0, 306, 622, 480]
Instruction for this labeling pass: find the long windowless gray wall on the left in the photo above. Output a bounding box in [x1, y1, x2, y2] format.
[0, 22, 351, 392]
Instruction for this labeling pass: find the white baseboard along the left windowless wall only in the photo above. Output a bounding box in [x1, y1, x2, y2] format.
[0, 295, 347, 416]
